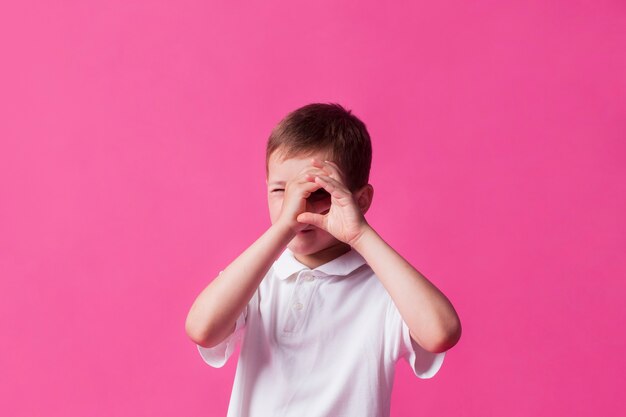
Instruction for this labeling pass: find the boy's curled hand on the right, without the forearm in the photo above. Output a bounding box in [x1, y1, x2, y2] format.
[297, 160, 367, 246]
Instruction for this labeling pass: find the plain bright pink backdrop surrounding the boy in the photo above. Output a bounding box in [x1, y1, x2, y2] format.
[0, 0, 626, 417]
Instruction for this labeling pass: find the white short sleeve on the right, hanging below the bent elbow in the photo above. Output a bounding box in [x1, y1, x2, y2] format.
[386, 297, 446, 379]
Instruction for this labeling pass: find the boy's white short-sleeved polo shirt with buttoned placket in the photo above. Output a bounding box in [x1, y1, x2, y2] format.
[197, 248, 445, 417]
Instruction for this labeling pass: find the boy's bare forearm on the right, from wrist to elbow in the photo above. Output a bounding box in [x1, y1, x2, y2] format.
[353, 225, 461, 352]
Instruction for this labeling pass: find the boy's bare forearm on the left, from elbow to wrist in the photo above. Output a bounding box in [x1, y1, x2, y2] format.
[185, 223, 294, 347]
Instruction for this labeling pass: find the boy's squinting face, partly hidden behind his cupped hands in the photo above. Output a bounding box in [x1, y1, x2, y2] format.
[267, 152, 343, 255]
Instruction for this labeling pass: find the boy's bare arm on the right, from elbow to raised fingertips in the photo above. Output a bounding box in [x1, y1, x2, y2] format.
[298, 160, 461, 353]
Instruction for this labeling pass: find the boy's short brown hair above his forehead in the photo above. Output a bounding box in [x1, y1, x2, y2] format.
[265, 103, 372, 191]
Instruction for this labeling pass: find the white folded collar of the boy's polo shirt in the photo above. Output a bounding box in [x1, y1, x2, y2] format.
[273, 247, 366, 280]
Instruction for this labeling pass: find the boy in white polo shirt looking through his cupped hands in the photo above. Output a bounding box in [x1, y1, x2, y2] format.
[185, 103, 461, 417]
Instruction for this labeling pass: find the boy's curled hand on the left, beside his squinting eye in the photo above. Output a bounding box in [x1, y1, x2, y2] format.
[276, 164, 330, 233]
